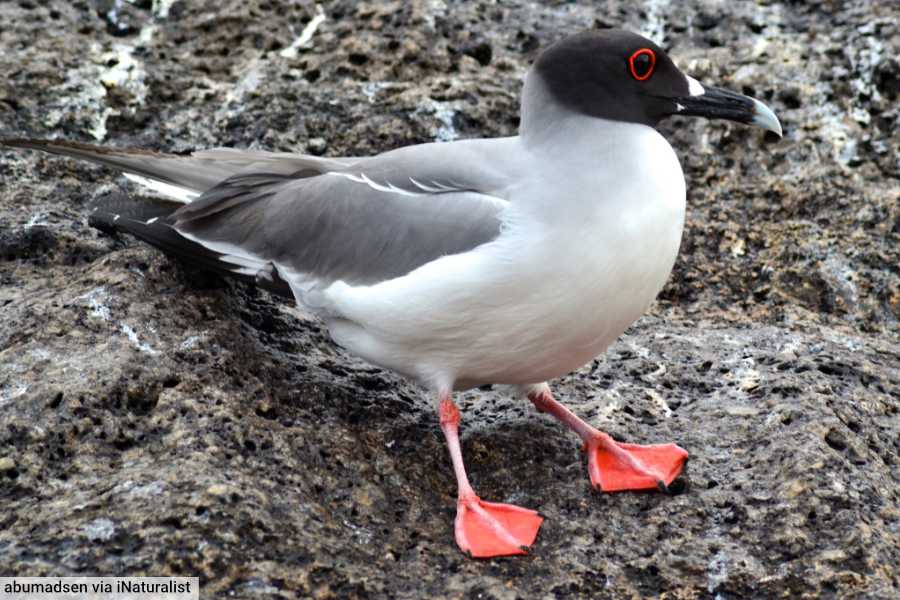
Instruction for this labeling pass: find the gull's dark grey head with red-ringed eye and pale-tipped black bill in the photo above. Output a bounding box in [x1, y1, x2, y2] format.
[534, 29, 781, 135]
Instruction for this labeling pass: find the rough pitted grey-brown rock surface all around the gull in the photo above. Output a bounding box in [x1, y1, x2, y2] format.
[0, 0, 900, 599]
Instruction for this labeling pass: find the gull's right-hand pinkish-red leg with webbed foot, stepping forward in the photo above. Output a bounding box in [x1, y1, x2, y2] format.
[528, 387, 688, 492]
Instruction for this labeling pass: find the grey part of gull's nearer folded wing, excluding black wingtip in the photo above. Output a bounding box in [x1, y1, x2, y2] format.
[168, 151, 507, 284]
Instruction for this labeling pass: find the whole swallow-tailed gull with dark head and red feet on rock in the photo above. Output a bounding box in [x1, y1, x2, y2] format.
[4, 30, 781, 557]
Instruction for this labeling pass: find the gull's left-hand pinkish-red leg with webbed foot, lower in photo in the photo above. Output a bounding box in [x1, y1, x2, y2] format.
[440, 394, 544, 558]
